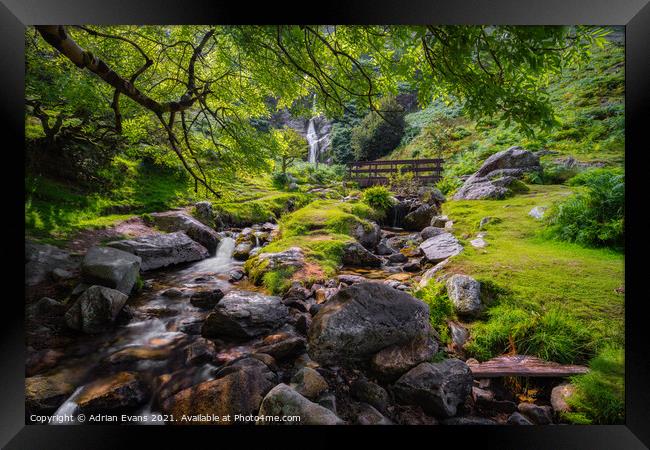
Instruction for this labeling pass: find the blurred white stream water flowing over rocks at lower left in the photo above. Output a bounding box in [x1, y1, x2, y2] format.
[51, 237, 258, 424]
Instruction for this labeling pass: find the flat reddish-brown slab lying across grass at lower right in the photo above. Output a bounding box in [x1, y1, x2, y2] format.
[467, 355, 589, 378]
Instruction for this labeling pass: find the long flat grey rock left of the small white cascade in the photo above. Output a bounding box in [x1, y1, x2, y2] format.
[106, 231, 209, 271]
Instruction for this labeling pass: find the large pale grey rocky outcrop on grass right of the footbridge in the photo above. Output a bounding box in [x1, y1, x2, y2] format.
[454, 147, 541, 200]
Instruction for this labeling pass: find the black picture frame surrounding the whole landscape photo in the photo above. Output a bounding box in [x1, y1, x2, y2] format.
[0, 0, 650, 449]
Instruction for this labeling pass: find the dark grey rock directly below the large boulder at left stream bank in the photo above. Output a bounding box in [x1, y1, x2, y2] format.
[65, 286, 128, 333]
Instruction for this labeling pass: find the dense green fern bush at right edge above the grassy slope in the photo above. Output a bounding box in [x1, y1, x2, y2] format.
[547, 169, 625, 248]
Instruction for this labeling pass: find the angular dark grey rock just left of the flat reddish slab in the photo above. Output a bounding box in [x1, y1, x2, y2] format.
[393, 359, 474, 417]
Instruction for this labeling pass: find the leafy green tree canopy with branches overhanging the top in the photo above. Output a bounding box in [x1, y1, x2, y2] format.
[27, 25, 604, 196]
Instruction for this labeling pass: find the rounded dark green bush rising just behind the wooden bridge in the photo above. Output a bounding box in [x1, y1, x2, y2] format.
[350, 97, 404, 161]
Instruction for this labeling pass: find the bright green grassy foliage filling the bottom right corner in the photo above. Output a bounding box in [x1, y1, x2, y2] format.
[563, 346, 625, 424]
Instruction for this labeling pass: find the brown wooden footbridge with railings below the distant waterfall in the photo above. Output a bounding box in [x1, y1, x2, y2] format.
[348, 158, 444, 187]
